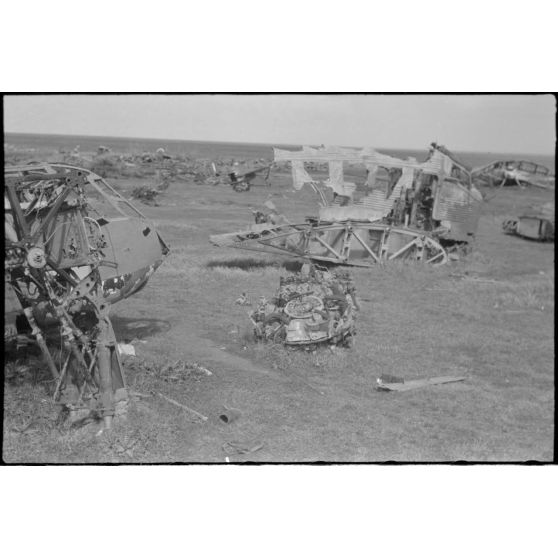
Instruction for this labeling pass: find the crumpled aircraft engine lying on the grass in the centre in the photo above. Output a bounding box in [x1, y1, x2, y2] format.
[249, 264, 358, 350]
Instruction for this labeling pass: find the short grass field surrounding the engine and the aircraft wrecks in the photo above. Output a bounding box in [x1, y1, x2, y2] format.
[3, 149, 554, 463]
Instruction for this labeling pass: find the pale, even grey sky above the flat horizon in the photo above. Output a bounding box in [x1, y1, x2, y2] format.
[4, 95, 556, 154]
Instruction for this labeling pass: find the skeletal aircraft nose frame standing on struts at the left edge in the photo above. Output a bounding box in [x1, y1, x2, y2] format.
[4, 163, 169, 428]
